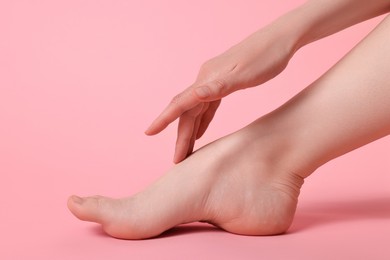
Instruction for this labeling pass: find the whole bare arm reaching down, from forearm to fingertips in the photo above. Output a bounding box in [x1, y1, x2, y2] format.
[145, 0, 390, 163]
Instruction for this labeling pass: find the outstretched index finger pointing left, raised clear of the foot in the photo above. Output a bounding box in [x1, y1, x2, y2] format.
[145, 87, 201, 135]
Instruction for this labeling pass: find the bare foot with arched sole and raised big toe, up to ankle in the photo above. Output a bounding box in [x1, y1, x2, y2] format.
[68, 118, 303, 239]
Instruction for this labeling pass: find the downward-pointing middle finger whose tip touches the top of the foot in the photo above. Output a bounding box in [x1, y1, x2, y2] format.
[173, 103, 203, 163]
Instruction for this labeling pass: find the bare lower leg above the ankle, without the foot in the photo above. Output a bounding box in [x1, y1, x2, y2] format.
[269, 16, 390, 177]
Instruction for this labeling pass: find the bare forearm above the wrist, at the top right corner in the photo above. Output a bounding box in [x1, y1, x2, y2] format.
[275, 0, 390, 51]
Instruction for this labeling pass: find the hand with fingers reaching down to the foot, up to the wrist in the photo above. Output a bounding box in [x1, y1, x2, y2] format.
[145, 25, 295, 163]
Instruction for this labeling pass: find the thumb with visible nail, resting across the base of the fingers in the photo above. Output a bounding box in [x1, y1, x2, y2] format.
[194, 78, 236, 102]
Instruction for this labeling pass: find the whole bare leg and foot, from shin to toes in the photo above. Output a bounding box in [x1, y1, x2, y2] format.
[68, 18, 390, 239]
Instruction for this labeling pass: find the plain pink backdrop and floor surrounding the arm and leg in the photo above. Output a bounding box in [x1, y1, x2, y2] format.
[0, 0, 390, 259]
